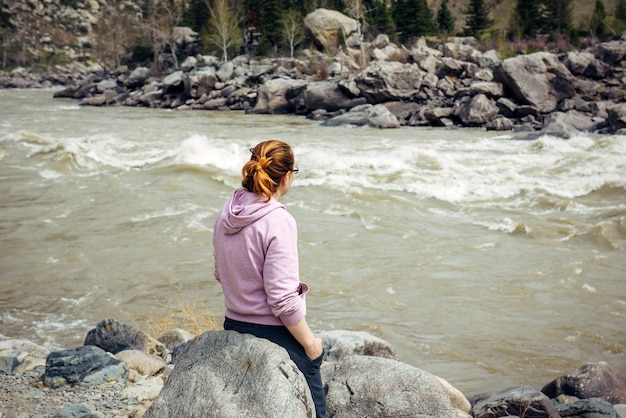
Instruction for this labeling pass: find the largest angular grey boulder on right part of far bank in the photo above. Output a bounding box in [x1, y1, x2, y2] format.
[494, 52, 575, 113]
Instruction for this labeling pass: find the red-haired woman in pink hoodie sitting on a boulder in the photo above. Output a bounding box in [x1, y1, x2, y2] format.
[213, 140, 328, 417]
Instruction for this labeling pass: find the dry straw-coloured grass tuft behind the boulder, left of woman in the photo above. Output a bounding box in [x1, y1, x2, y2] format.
[141, 297, 221, 338]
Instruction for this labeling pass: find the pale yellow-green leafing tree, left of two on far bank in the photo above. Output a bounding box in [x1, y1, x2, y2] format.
[204, 0, 243, 61]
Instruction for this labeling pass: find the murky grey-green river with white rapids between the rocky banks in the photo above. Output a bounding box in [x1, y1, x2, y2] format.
[0, 90, 626, 395]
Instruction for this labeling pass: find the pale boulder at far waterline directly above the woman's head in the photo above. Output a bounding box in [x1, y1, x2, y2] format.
[247, 78, 307, 114]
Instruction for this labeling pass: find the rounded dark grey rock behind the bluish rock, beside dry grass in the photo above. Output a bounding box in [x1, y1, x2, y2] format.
[84, 319, 167, 358]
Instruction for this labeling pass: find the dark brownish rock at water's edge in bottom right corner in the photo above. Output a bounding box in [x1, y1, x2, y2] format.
[541, 361, 626, 404]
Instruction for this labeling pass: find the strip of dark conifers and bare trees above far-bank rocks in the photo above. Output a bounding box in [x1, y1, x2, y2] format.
[0, 0, 626, 74]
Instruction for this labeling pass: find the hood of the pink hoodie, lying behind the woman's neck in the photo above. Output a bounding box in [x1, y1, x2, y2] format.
[223, 189, 285, 235]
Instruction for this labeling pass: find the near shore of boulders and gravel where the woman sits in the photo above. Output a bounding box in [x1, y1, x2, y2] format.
[0, 319, 626, 418]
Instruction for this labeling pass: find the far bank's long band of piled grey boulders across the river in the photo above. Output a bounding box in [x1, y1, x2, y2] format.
[0, 33, 626, 138]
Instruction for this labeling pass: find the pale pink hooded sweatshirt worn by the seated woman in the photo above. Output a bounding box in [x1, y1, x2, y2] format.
[213, 189, 308, 325]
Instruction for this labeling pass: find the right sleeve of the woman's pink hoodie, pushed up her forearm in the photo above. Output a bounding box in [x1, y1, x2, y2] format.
[263, 209, 308, 325]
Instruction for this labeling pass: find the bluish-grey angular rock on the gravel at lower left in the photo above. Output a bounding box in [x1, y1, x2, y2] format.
[43, 345, 128, 388]
